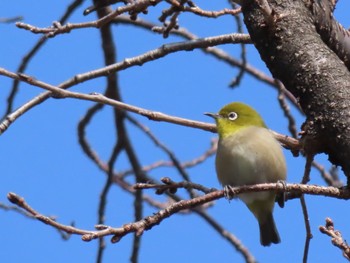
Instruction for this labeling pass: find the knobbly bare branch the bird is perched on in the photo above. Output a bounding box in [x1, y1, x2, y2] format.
[8, 183, 350, 243]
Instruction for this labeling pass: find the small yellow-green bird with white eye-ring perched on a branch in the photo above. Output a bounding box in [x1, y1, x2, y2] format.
[205, 102, 286, 246]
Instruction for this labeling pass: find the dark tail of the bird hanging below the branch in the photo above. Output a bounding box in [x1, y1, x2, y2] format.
[258, 212, 281, 246]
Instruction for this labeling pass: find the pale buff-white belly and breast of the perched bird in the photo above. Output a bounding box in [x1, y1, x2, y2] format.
[216, 127, 286, 204]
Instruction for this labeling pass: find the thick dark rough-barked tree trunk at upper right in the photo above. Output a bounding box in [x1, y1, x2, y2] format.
[241, 0, 350, 185]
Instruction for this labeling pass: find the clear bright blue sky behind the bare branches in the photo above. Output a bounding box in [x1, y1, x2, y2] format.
[0, 0, 350, 263]
